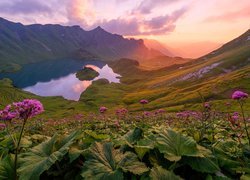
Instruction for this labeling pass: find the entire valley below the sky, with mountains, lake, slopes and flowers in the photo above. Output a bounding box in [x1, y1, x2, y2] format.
[0, 15, 250, 180]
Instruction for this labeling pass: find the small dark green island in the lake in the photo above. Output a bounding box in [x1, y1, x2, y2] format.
[76, 67, 99, 81]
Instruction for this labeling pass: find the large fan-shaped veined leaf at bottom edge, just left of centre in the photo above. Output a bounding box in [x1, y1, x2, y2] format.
[81, 142, 148, 179]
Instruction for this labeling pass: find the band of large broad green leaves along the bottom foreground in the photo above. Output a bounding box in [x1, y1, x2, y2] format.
[0, 126, 250, 180]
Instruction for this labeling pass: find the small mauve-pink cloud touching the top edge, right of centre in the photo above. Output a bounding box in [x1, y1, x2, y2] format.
[132, 0, 178, 14]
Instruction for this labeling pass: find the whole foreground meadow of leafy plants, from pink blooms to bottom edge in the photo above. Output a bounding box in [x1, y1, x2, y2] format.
[0, 101, 250, 180]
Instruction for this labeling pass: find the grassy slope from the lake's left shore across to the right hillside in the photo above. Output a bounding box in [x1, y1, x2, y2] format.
[0, 29, 250, 116]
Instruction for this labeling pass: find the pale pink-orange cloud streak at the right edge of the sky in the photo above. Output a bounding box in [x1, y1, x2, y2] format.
[205, 6, 250, 22]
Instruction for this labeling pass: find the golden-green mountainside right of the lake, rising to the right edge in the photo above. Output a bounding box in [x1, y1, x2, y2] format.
[81, 30, 250, 111]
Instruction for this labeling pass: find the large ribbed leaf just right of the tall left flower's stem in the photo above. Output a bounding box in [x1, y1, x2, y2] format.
[18, 131, 78, 180]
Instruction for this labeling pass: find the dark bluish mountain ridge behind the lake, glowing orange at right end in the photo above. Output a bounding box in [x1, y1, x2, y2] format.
[0, 18, 161, 71]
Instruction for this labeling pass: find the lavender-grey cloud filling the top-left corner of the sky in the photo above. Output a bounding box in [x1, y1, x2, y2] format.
[0, 0, 52, 15]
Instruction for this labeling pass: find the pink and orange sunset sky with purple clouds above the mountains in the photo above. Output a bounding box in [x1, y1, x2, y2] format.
[0, 0, 250, 57]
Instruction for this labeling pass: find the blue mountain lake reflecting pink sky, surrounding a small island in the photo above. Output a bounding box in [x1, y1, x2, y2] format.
[0, 59, 120, 101]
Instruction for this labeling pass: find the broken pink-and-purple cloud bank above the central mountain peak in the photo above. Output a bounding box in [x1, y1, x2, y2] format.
[67, 0, 188, 36]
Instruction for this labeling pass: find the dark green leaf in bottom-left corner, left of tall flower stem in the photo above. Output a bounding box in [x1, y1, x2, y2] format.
[0, 155, 15, 180]
